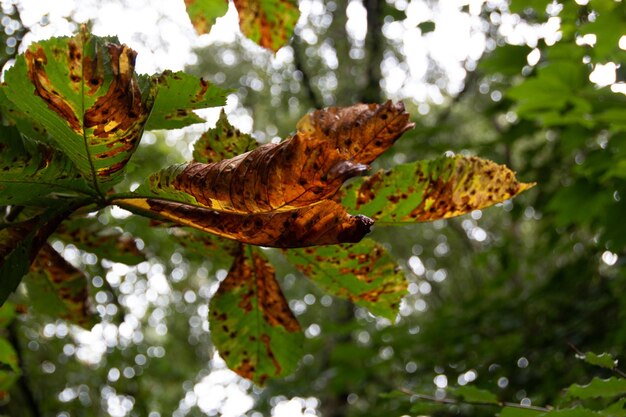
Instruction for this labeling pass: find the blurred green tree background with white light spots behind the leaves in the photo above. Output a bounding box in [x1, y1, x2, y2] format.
[0, 0, 626, 417]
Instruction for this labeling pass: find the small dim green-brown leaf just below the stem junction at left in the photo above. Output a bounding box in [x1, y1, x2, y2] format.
[54, 217, 146, 265]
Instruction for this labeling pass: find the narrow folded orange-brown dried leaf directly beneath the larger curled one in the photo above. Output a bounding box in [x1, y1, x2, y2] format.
[114, 199, 372, 248]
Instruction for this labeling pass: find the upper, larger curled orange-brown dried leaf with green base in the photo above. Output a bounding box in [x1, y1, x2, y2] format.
[133, 101, 413, 213]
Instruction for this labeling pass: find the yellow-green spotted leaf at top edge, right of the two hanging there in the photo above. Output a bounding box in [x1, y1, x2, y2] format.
[234, 0, 300, 52]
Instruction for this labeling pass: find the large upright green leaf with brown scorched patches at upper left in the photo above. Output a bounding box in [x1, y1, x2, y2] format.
[3, 29, 149, 192]
